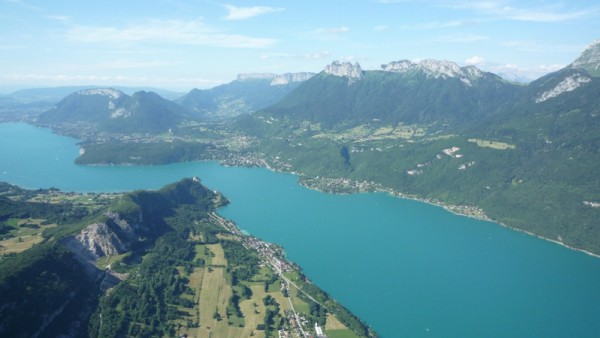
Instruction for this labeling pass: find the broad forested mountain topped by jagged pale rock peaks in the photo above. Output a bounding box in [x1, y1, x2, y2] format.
[264, 60, 519, 128]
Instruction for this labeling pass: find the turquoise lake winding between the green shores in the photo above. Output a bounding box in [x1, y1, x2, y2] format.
[0, 124, 600, 337]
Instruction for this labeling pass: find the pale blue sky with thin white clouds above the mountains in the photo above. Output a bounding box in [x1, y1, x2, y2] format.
[0, 0, 600, 93]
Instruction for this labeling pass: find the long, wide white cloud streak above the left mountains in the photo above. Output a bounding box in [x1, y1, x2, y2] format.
[67, 20, 276, 48]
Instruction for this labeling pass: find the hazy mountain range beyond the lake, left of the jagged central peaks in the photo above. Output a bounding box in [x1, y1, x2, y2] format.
[25, 73, 314, 133]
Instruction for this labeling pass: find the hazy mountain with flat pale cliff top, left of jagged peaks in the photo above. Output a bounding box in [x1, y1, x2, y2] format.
[175, 73, 314, 119]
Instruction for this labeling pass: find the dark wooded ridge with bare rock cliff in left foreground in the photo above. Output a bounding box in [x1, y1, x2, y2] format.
[0, 179, 217, 337]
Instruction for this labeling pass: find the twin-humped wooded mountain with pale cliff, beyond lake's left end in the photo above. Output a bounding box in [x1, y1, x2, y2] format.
[38, 88, 187, 133]
